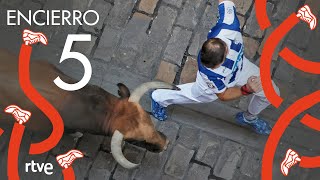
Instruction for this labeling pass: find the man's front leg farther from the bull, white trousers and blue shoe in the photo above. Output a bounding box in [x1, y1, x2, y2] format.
[236, 57, 280, 134]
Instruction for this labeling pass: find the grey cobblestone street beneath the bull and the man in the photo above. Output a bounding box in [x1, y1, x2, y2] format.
[0, 0, 320, 180]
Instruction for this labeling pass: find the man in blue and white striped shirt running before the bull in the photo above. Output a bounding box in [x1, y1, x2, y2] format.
[151, 0, 279, 135]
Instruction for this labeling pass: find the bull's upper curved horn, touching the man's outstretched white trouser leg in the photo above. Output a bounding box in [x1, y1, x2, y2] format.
[129, 81, 180, 103]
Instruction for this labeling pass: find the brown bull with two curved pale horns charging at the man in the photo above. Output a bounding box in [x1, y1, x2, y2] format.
[0, 50, 178, 168]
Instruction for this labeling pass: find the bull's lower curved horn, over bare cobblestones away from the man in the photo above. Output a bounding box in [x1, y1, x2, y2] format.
[111, 130, 139, 169]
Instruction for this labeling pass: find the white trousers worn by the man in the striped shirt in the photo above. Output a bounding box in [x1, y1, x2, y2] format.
[152, 58, 280, 115]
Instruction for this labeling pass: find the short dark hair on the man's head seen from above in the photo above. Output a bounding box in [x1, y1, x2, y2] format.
[201, 38, 227, 68]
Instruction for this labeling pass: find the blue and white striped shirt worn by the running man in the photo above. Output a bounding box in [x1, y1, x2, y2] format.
[198, 1, 244, 93]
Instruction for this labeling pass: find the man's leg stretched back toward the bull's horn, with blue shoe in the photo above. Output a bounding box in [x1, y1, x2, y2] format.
[151, 78, 218, 121]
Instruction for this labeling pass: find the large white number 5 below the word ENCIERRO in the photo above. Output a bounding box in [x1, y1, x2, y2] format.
[53, 34, 92, 91]
